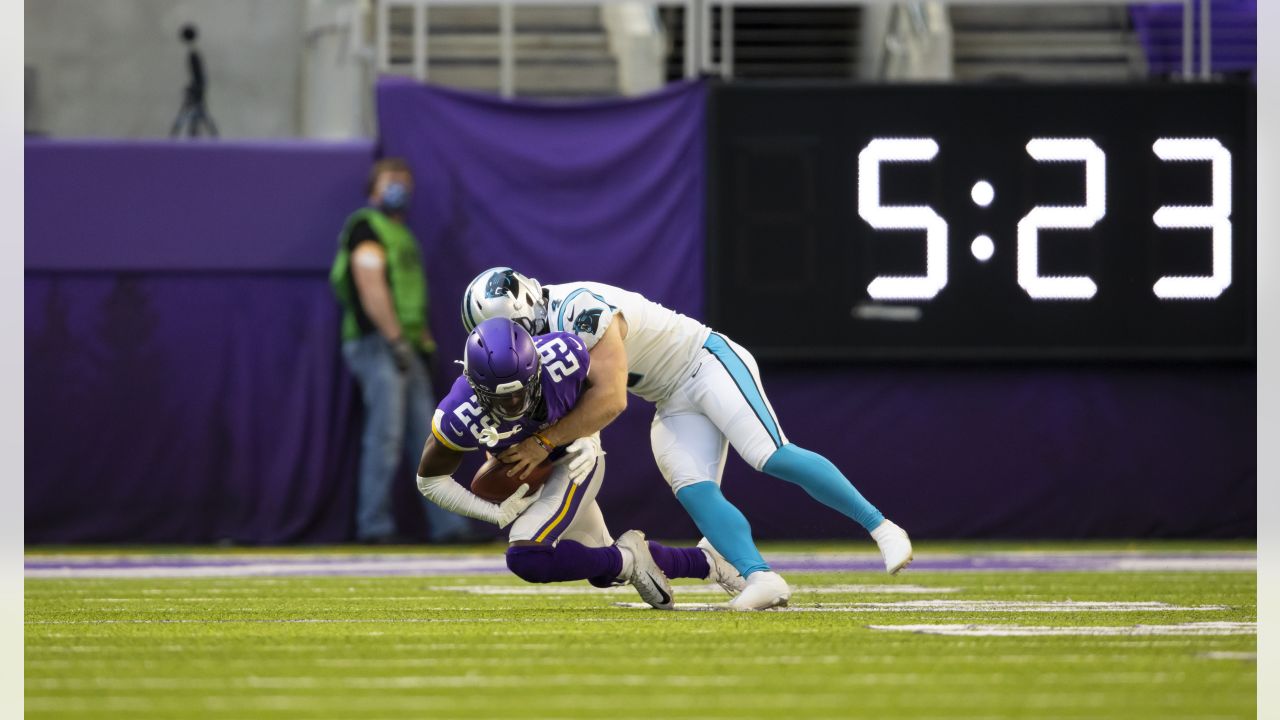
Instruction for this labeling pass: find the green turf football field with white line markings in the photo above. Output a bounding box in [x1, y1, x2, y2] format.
[26, 541, 1257, 720]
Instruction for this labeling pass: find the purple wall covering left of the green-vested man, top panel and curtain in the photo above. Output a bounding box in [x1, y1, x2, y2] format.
[24, 141, 373, 542]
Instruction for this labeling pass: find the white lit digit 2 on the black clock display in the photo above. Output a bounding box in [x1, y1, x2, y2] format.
[1018, 137, 1107, 300]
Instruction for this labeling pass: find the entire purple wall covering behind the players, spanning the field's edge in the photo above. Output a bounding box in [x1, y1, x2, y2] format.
[24, 82, 1257, 543]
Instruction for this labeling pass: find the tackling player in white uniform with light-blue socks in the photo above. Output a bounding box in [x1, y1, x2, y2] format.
[462, 268, 911, 610]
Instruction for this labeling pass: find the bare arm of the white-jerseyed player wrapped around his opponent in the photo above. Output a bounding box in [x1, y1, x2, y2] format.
[500, 315, 627, 478]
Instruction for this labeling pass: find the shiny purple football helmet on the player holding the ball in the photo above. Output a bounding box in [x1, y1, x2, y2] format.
[462, 318, 543, 420]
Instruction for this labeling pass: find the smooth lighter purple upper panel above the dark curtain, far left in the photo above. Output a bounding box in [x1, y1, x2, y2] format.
[24, 140, 372, 273]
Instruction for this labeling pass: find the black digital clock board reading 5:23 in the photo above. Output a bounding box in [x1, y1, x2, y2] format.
[707, 83, 1257, 360]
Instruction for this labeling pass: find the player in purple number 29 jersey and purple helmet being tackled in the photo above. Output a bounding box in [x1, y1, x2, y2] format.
[417, 318, 744, 610]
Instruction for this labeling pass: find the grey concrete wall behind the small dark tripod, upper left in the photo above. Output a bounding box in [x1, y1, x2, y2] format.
[23, 0, 307, 138]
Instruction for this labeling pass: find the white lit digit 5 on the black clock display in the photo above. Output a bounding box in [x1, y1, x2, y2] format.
[858, 137, 947, 300]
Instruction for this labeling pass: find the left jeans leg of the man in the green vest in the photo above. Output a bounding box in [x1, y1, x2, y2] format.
[343, 334, 404, 542]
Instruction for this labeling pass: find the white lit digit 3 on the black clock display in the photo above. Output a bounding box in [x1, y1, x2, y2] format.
[1152, 137, 1231, 300]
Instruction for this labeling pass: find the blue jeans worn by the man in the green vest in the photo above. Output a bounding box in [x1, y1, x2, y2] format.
[342, 333, 470, 542]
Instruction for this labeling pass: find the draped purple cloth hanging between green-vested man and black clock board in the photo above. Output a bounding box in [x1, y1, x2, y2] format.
[378, 78, 705, 348]
